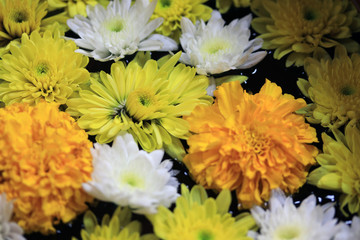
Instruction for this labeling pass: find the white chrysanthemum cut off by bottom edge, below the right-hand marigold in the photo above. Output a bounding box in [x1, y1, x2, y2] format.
[249, 189, 339, 240]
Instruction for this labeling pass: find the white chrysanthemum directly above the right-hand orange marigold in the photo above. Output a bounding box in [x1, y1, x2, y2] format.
[180, 11, 266, 75]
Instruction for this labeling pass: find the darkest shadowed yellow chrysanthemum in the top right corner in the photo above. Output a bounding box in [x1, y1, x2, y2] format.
[251, 0, 360, 67]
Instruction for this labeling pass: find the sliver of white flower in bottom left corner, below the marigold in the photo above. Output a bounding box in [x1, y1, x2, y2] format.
[0, 193, 25, 240]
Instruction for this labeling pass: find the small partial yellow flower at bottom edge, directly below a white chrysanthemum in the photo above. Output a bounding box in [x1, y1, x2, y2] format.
[73, 207, 158, 240]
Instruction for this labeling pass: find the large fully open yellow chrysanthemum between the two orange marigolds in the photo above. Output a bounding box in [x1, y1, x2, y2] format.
[67, 52, 212, 159]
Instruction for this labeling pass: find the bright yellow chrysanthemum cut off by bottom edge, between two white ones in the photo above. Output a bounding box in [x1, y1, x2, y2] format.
[148, 184, 255, 240]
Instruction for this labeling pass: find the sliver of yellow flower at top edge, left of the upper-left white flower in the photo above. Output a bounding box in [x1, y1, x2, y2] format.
[48, 0, 109, 18]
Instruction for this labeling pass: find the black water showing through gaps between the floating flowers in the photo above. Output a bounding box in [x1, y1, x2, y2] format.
[25, 0, 360, 240]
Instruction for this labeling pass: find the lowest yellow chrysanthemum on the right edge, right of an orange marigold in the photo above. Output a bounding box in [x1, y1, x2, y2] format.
[308, 124, 360, 215]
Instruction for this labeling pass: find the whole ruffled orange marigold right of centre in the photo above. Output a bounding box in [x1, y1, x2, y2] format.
[184, 80, 317, 208]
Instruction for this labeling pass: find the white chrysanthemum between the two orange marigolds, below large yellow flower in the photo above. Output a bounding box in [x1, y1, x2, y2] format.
[83, 133, 179, 214]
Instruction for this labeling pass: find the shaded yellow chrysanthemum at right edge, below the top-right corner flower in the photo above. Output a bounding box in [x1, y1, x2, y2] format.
[298, 46, 360, 128]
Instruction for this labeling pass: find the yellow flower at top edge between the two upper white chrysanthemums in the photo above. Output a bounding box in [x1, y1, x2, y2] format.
[151, 0, 212, 41]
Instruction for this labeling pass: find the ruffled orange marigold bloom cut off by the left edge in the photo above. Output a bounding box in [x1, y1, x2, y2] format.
[0, 102, 92, 234]
